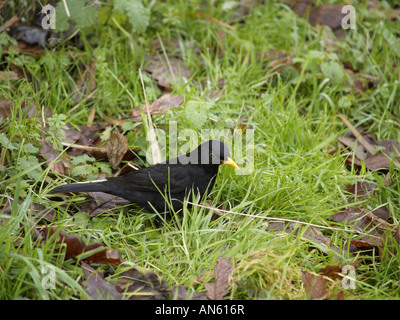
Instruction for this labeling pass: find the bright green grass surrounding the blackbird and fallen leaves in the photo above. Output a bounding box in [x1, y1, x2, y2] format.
[0, 1, 400, 300]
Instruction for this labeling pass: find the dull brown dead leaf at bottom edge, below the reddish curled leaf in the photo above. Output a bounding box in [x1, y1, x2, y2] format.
[81, 261, 123, 300]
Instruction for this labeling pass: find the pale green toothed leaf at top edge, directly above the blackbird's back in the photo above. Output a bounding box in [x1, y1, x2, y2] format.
[114, 0, 150, 32]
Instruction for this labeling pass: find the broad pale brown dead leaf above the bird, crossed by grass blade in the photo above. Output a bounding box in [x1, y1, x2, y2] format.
[145, 55, 191, 91]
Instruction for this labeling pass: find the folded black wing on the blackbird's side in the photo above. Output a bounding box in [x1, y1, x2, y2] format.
[108, 164, 194, 193]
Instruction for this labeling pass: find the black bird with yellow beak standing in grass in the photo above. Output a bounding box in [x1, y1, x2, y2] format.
[52, 140, 238, 212]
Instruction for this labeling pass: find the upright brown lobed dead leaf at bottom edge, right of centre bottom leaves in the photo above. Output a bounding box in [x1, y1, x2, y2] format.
[205, 257, 233, 300]
